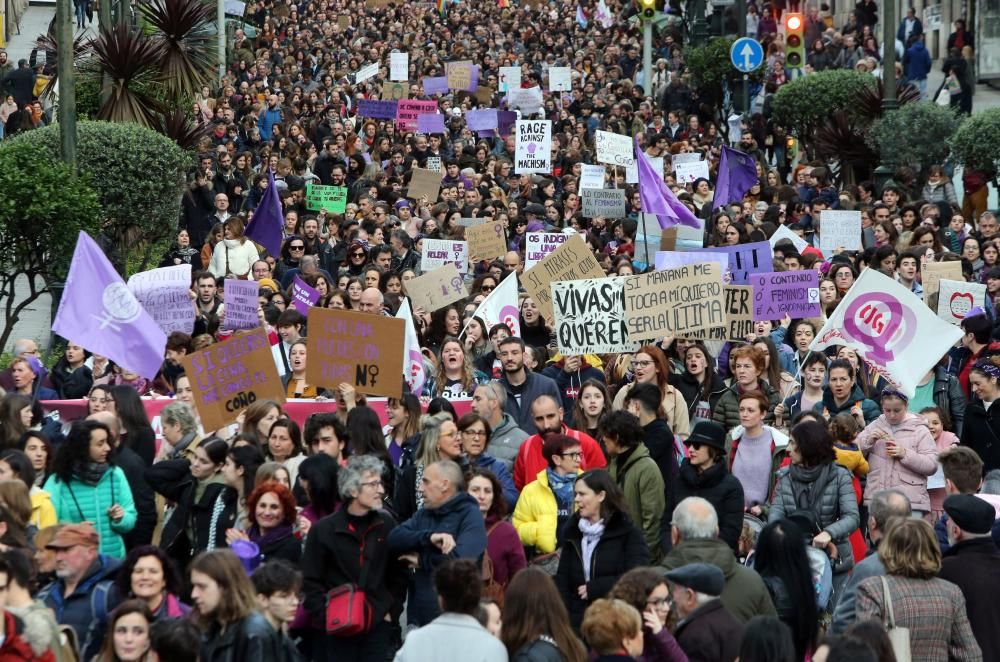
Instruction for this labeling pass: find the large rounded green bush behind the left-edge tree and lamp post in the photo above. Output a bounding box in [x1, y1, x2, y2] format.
[9, 121, 191, 274]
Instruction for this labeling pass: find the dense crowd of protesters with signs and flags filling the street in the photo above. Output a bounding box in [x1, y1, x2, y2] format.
[0, 0, 1000, 662]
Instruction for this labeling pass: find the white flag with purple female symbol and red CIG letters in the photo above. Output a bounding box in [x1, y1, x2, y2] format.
[809, 262, 962, 398]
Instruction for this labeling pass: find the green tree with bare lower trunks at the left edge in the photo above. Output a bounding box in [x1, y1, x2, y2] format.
[0, 143, 101, 356]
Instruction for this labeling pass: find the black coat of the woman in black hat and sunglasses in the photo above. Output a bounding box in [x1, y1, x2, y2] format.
[663, 459, 743, 550]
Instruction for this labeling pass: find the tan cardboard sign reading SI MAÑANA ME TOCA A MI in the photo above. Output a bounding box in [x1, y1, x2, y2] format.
[625, 262, 726, 341]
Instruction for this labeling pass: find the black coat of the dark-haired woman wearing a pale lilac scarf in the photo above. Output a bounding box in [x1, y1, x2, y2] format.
[555, 512, 649, 630]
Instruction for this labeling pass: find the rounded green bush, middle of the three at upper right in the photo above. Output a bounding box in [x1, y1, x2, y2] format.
[865, 101, 961, 171]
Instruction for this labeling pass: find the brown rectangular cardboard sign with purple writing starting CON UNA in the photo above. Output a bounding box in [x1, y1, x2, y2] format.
[304, 308, 406, 398]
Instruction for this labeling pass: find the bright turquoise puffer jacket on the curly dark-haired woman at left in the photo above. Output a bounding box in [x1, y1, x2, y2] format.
[44, 467, 138, 559]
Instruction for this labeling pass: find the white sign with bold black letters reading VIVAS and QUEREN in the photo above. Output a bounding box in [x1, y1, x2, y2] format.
[552, 277, 639, 355]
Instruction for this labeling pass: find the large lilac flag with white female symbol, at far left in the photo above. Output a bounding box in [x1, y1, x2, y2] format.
[52, 232, 167, 379]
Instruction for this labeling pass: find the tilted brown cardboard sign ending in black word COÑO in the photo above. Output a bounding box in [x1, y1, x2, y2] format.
[181, 330, 285, 430]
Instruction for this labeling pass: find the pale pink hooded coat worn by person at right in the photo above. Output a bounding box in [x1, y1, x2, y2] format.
[857, 413, 938, 512]
